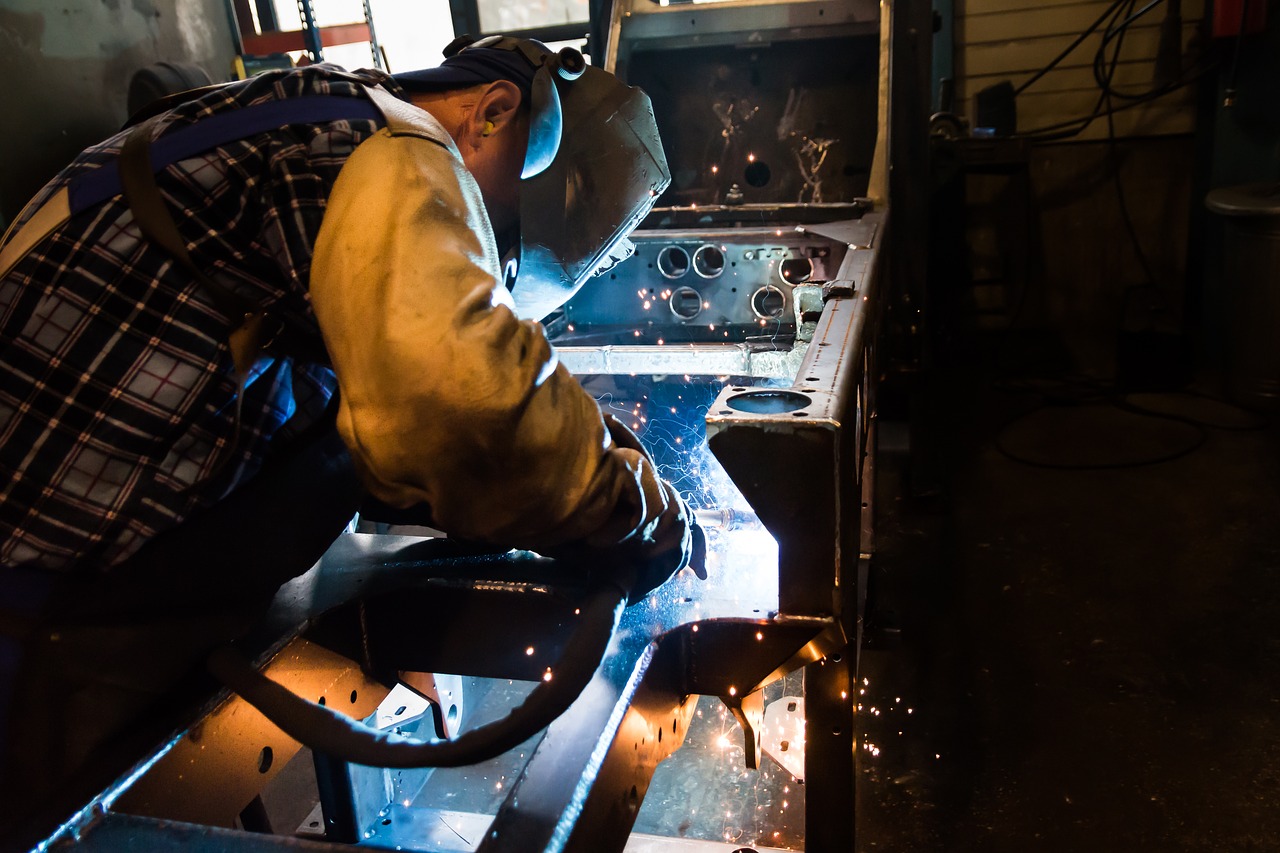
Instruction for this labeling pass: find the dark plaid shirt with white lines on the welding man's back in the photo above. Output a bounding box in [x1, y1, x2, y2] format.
[0, 65, 398, 570]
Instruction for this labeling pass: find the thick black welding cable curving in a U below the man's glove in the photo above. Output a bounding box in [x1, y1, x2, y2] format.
[207, 583, 626, 768]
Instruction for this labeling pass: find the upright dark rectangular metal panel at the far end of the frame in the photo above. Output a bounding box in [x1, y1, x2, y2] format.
[605, 0, 882, 211]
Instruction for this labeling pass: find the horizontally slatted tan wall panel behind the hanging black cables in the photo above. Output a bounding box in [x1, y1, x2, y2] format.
[956, 0, 1204, 140]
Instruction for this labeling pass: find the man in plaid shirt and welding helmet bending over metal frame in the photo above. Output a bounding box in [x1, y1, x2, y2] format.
[0, 37, 691, 847]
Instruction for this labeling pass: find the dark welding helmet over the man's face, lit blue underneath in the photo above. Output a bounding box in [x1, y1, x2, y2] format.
[394, 36, 671, 319]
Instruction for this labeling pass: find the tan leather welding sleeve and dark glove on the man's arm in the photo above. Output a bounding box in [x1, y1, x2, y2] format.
[311, 131, 690, 576]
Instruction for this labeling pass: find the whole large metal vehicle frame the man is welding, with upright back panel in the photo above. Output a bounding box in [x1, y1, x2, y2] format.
[42, 0, 896, 853]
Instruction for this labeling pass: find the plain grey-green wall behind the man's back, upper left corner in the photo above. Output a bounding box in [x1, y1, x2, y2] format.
[0, 0, 233, 225]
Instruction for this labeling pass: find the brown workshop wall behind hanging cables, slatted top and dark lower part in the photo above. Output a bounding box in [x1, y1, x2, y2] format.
[955, 0, 1212, 382]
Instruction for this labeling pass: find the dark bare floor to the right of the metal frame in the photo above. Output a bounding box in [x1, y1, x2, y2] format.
[858, 330, 1280, 853]
